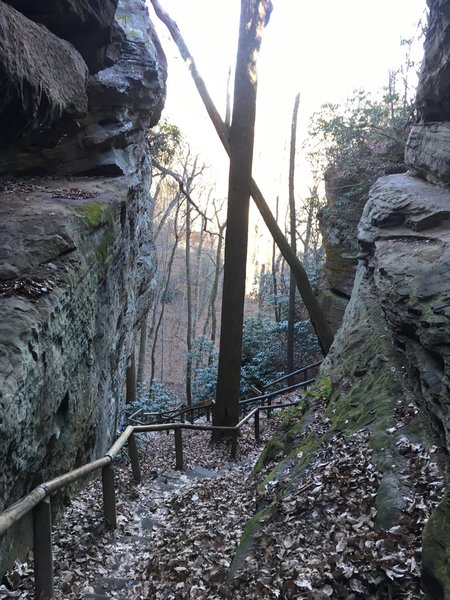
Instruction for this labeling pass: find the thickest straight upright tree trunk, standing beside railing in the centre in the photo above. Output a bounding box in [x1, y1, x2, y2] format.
[213, 0, 269, 437]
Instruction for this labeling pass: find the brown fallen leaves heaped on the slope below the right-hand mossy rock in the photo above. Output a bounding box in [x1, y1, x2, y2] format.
[233, 424, 443, 600]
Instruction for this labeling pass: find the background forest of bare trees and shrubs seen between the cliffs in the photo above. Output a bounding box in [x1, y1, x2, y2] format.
[129, 14, 424, 418]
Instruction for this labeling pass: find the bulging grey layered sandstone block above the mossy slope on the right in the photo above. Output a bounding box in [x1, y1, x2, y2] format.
[359, 175, 450, 451]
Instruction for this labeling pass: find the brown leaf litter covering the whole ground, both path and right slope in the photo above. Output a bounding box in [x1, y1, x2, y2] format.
[0, 394, 443, 600]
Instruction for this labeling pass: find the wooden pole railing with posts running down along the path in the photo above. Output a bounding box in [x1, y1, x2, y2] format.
[0, 364, 314, 600]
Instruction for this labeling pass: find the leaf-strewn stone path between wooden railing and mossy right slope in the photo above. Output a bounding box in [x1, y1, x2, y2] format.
[0, 418, 282, 600]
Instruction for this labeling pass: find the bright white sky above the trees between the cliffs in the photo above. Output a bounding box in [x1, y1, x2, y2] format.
[150, 0, 426, 272]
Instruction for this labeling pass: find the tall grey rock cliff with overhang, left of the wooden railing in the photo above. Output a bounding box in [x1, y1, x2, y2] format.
[0, 0, 166, 571]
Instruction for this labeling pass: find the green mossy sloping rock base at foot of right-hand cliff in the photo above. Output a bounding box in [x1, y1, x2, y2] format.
[230, 264, 448, 600]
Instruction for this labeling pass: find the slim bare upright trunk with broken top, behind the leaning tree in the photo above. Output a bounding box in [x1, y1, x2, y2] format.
[286, 94, 300, 385]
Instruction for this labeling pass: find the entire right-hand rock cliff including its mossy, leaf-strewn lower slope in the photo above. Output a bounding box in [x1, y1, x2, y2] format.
[234, 0, 450, 600]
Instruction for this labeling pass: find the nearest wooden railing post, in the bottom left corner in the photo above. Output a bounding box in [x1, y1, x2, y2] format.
[33, 498, 53, 600]
